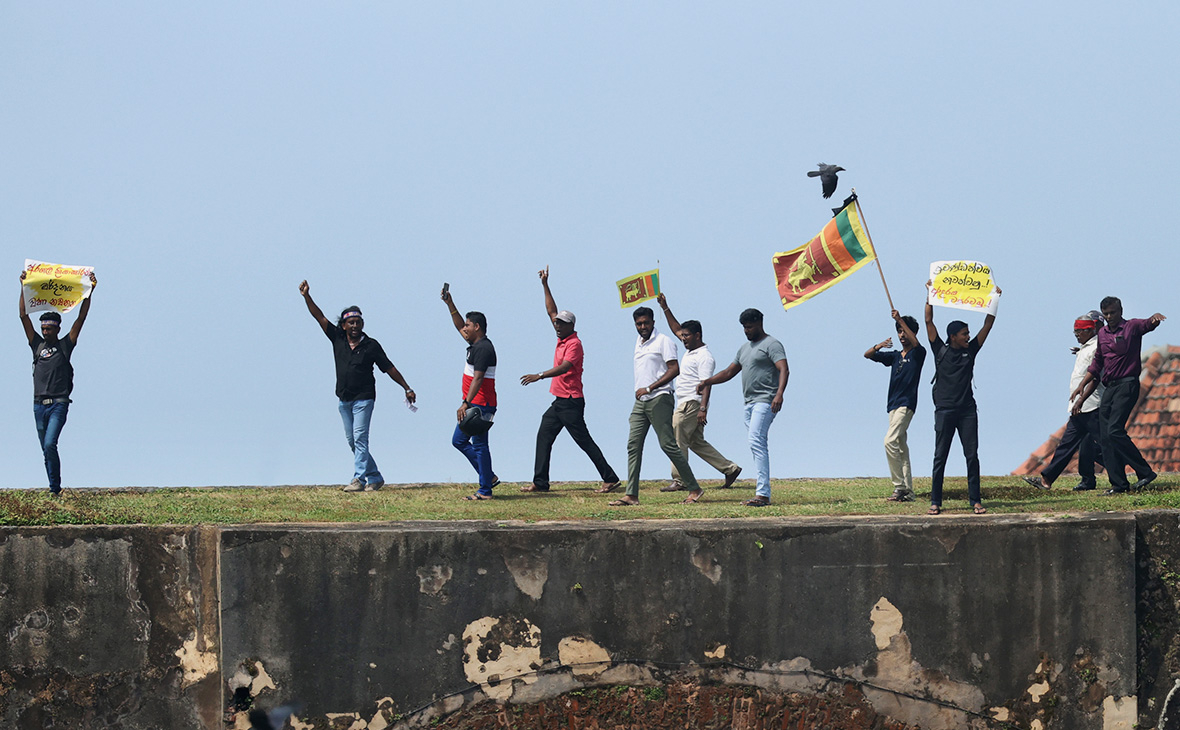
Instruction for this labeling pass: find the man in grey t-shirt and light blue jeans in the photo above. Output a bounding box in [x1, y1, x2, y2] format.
[696, 309, 791, 507]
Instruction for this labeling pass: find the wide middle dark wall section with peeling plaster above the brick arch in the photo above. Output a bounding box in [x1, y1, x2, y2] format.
[221, 515, 1132, 730]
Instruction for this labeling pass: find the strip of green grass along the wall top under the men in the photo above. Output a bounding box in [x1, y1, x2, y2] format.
[0, 474, 1180, 526]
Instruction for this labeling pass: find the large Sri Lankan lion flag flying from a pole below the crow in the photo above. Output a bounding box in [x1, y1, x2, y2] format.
[774, 202, 877, 309]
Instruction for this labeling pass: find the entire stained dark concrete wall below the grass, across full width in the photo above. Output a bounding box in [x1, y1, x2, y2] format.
[0, 513, 1161, 730]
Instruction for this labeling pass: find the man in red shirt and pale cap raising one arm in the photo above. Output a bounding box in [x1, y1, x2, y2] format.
[520, 267, 618, 492]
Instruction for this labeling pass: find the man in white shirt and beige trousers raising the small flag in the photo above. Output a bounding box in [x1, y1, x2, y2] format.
[656, 294, 741, 501]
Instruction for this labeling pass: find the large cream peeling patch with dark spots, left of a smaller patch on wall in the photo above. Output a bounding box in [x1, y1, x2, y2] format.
[463, 616, 540, 702]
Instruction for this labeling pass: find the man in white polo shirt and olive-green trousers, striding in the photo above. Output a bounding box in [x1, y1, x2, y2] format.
[598, 307, 701, 507]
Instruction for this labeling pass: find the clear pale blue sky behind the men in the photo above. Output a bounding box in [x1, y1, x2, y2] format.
[0, 2, 1180, 487]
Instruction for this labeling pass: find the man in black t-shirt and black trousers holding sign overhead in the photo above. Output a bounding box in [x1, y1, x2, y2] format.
[926, 281, 1001, 514]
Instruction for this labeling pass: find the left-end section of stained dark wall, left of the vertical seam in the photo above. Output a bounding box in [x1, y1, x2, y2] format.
[0, 527, 221, 730]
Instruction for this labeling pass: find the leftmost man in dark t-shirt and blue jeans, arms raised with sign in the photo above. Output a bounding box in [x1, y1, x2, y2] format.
[20, 271, 98, 494]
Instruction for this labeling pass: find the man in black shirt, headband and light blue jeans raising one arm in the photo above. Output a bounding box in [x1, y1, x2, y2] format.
[299, 279, 418, 492]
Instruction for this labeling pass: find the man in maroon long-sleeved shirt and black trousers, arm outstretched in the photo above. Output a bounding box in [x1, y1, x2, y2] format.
[1070, 296, 1167, 494]
